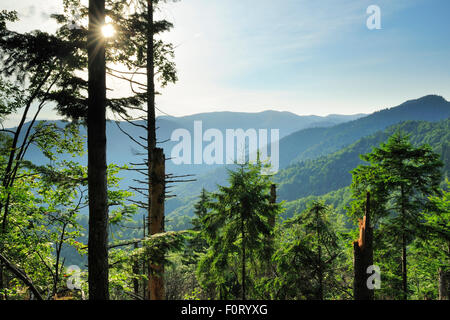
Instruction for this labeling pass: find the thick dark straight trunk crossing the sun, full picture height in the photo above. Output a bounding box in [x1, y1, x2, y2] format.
[87, 0, 109, 300]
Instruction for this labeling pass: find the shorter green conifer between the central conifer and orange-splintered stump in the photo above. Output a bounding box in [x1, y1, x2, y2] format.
[271, 201, 345, 300]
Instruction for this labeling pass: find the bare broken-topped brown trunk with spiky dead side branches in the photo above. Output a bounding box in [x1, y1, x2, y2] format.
[148, 148, 165, 300]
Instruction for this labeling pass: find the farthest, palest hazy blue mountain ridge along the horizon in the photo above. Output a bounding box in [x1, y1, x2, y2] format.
[15, 111, 364, 181]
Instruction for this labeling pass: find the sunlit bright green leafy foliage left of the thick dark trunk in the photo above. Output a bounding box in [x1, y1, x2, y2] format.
[0, 124, 85, 298]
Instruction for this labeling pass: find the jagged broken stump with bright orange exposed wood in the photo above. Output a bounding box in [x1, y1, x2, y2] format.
[353, 192, 374, 300]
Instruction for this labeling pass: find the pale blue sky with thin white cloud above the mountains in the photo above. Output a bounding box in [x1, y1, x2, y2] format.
[0, 0, 450, 125]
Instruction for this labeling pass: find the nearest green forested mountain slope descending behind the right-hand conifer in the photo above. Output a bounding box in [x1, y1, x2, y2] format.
[275, 118, 450, 201]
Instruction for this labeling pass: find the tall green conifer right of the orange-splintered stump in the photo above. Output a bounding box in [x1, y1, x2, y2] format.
[353, 132, 442, 300]
